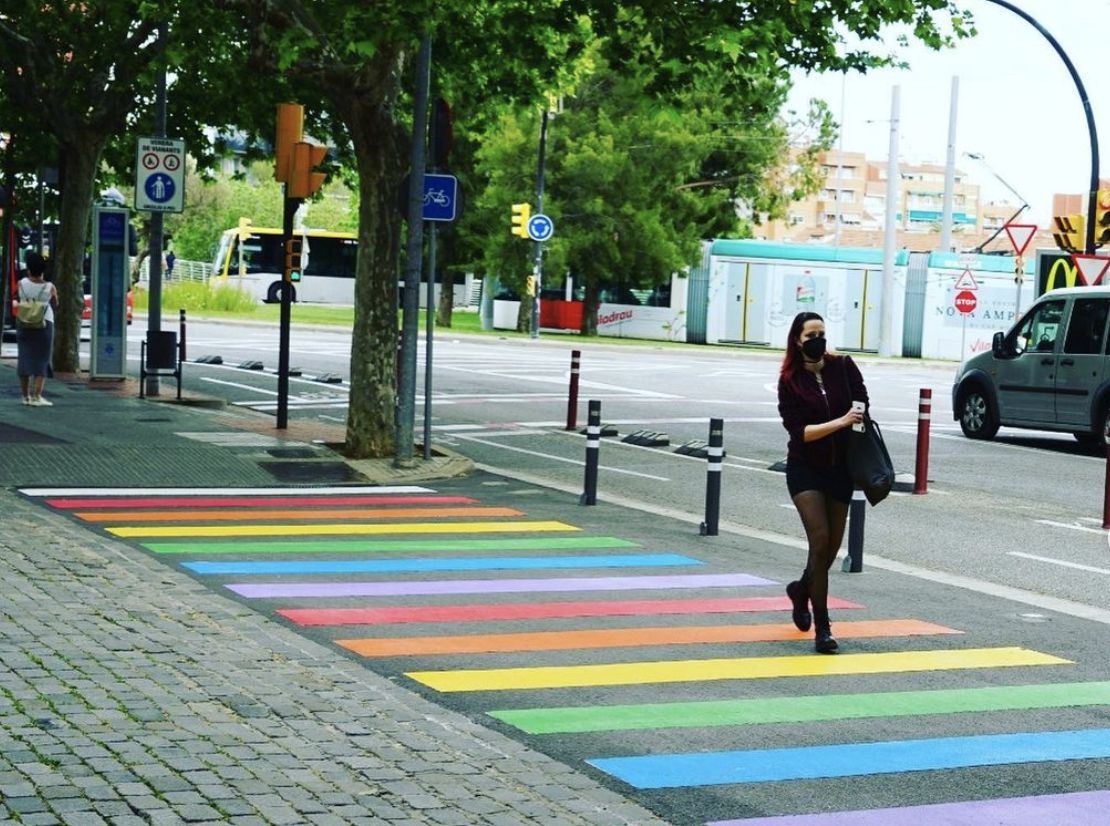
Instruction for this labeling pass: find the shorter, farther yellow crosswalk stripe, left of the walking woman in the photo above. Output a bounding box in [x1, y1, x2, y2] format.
[104, 522, 582, 537]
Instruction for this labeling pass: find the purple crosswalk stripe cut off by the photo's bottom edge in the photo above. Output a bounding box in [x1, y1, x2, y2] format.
[706, 792, 1110, 826]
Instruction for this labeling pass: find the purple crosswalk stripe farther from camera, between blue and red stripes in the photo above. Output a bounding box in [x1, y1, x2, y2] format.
[220, 574, 777, 600]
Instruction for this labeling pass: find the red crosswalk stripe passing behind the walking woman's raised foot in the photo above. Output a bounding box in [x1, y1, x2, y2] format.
[278, 596, 864, 625]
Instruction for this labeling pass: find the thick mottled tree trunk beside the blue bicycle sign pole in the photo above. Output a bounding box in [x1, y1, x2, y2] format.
[333, 89, 404, 459]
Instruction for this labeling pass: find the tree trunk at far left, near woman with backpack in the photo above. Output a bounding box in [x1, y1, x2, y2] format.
[52, 140, 105, 373]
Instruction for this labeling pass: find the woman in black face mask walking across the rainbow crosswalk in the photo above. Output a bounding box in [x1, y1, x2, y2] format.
[778, 312, 867, 654]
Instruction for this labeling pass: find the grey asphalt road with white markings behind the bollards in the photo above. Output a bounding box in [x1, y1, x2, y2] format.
[121, 322, 1110, 608]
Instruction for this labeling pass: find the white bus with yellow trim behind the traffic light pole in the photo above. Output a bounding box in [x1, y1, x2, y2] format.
[212, 226, 359, 304]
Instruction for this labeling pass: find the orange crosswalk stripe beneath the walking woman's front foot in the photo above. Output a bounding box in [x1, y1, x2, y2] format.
[335, 620, 963, 657]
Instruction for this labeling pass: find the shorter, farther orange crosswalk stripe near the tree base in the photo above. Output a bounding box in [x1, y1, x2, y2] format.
[74, 507, 524, 523]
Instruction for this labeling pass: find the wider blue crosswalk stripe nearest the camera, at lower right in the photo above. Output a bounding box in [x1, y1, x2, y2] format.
[587, 728, 1110, 788]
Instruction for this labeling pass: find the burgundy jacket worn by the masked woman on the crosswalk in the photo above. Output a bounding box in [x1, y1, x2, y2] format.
[778, 355, 868, 467]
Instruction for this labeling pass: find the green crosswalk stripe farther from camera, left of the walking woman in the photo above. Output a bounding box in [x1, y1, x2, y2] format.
[142, 536, 639, 554]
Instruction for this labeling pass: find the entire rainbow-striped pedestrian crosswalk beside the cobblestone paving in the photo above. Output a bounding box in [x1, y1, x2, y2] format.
[22, 486, 1110, 826]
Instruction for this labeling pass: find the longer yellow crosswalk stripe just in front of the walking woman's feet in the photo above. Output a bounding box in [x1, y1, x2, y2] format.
[406, 648, 1071, 693]
